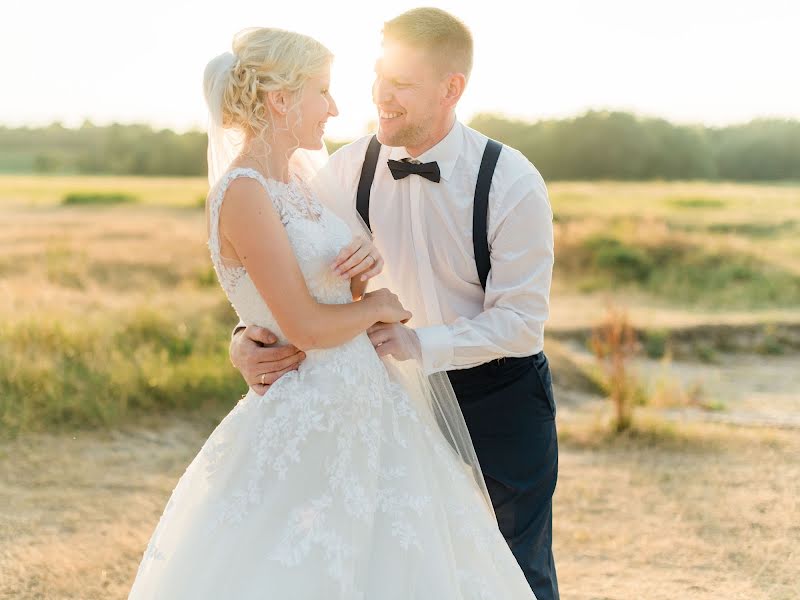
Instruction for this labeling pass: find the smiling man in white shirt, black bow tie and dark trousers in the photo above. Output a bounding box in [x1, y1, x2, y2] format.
[231, 8, 559, 600]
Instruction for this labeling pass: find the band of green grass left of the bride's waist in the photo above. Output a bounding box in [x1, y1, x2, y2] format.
[0, 308, 247, 436]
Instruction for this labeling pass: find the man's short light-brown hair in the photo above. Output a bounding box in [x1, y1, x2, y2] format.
[383, 8, 472, 79]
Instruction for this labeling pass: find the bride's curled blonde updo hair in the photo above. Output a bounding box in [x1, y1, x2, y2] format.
[222, 27, 333, 136]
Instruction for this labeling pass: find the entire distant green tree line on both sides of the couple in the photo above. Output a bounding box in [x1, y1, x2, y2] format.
[0, 111, 800, 181]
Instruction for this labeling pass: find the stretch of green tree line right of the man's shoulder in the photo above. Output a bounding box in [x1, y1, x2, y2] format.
[471, 111, 800, 181]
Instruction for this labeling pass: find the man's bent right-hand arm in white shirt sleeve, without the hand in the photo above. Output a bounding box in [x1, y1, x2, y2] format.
[416, 172, 553, 373]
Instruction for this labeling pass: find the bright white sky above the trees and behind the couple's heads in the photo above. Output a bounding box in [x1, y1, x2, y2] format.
[0, 0, 800, 139]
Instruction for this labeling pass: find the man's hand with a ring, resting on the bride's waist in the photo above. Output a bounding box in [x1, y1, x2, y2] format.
[230, 325, 306, 395]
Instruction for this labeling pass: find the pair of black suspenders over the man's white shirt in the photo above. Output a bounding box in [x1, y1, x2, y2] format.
[356, 136, 503, 289]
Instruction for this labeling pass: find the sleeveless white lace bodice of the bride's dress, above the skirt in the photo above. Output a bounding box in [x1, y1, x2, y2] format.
[208, 168, 352, 341]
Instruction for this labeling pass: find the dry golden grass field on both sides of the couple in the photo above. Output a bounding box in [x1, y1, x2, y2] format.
[0, 176, 800, 600]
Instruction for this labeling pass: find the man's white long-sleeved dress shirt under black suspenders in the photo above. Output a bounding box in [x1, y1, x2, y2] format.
[326, 121, 553, 374]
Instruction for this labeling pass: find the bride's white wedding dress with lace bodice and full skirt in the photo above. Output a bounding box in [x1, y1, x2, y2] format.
[129, 169, 534, 600]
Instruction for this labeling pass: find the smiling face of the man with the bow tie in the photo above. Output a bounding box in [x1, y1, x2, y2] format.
[372, 40, 453, 156]
